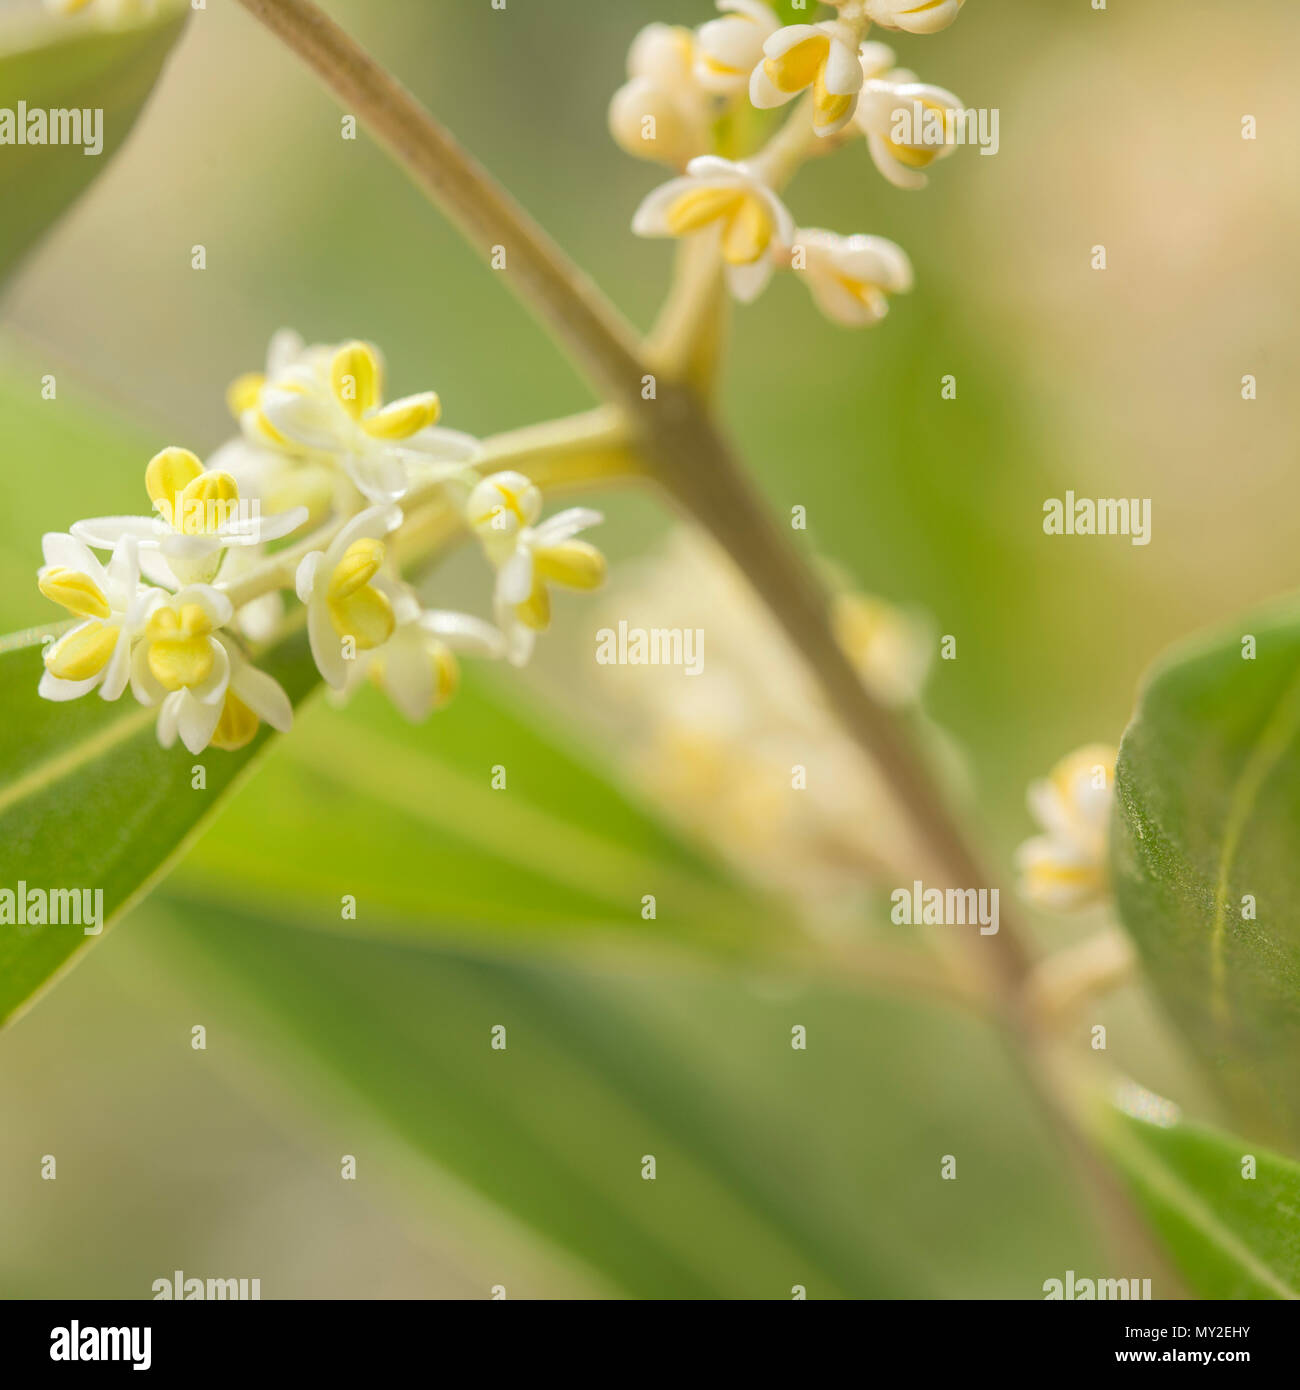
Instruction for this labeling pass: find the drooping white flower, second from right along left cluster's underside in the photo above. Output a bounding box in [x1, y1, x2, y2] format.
[348, 575, 505, 724]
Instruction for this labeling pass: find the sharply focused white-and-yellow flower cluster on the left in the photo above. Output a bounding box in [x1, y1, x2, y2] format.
[38, 331, 605, 753]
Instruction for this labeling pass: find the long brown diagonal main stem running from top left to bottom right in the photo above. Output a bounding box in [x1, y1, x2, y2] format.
[229, 0, 1158, 1262]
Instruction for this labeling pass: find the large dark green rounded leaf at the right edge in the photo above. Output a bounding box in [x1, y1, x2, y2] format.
[1112, 602, 1300, 1148]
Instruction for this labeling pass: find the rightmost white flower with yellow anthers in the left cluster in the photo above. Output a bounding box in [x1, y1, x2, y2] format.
[464, 473, 605, 666]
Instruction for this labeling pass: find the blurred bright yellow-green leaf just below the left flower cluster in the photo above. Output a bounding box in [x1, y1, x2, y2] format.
[178, 669, 794, 952]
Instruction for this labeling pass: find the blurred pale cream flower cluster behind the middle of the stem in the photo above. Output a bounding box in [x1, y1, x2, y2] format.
[595, 530, 934, 906]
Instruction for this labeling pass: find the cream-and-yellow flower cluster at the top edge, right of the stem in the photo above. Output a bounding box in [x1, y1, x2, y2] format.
[609, 0, 962, 327]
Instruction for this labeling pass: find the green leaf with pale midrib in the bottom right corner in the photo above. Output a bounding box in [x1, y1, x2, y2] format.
[1100, 1112, 1300, 1298]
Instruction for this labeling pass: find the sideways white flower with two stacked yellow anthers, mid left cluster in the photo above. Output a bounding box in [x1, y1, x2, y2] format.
[295, 506, 402, 689]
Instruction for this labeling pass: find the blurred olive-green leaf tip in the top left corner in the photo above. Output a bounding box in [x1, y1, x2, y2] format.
[0, 0, 189, 287]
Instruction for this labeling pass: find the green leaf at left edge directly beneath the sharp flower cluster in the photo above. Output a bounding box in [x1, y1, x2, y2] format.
[0, 631, 318, 1023]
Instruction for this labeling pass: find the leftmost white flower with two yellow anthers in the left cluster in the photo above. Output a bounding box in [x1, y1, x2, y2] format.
[38, 531, 165, 701]
